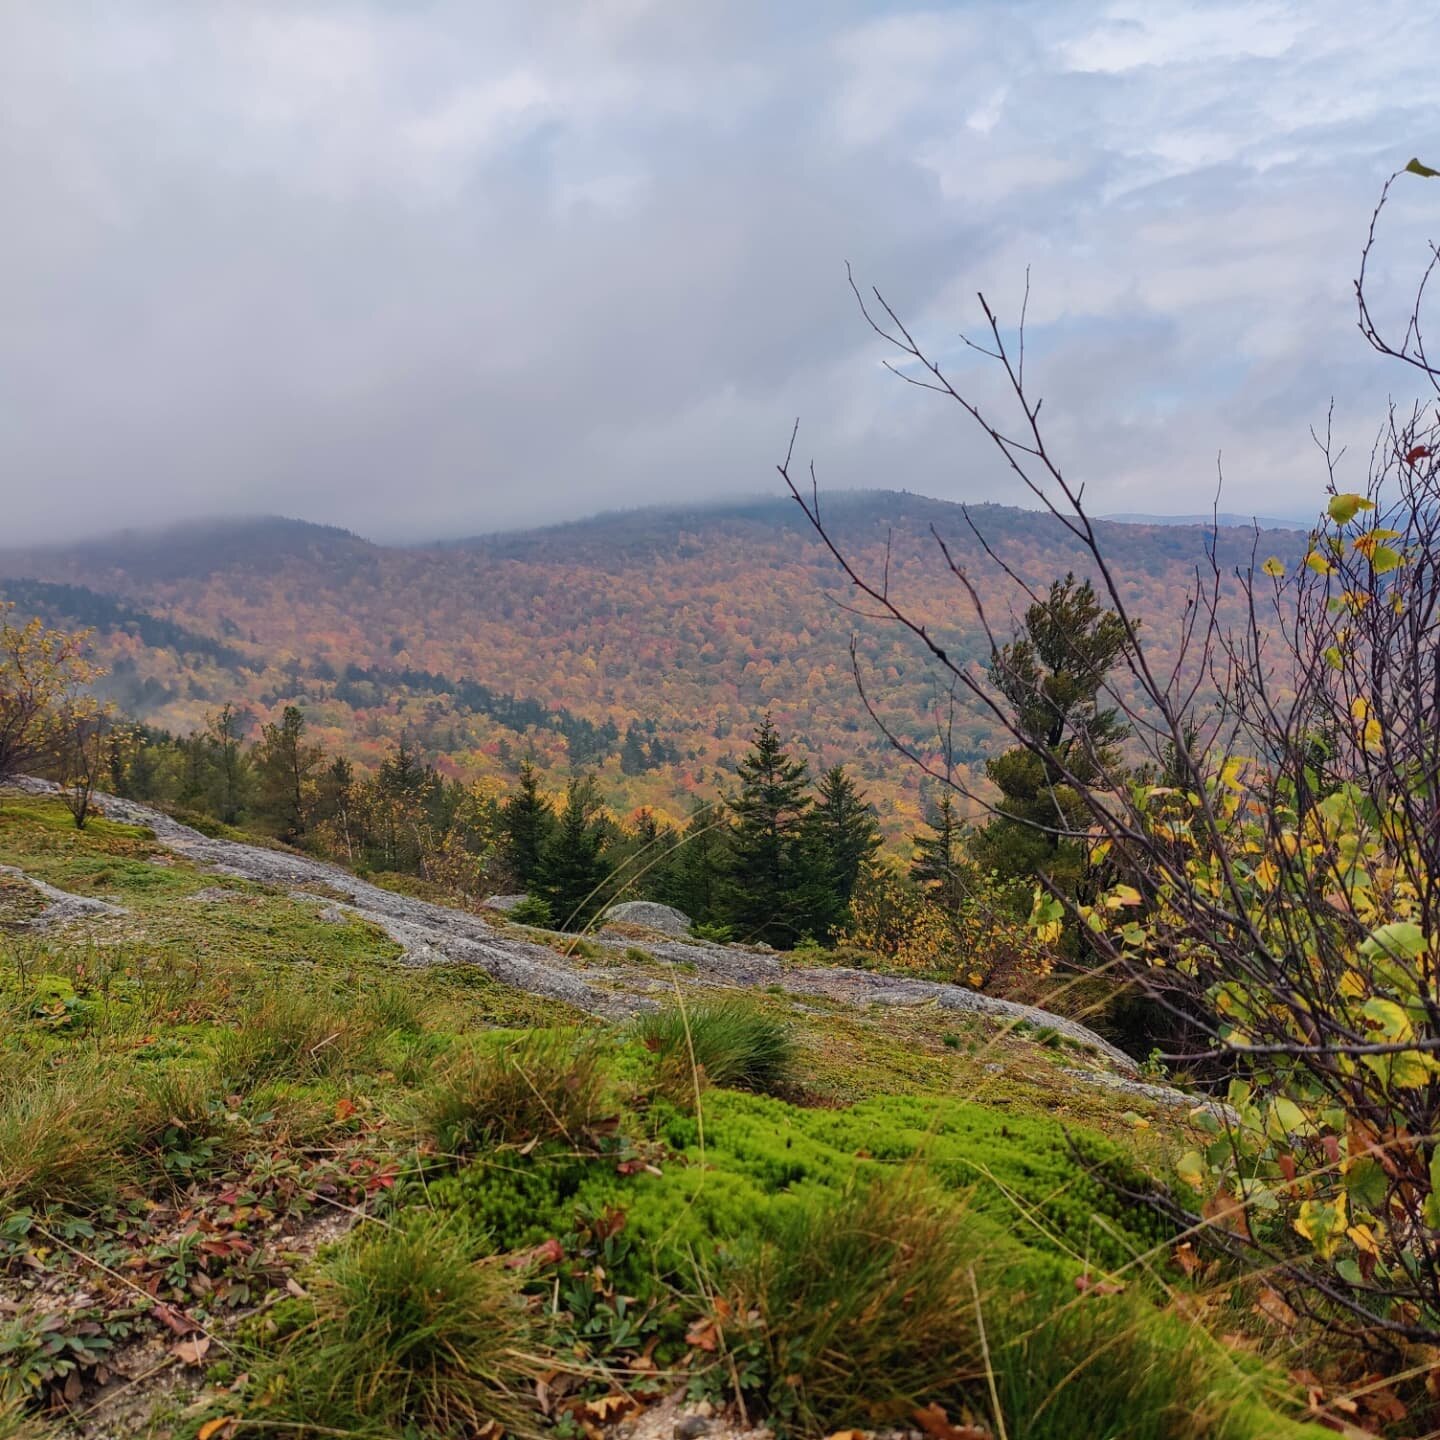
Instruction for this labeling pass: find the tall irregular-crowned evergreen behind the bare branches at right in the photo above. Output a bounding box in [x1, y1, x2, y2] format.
[971, 575, 1129, 891]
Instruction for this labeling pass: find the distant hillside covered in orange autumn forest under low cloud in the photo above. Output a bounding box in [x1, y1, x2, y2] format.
[0, 491, 1303, 835]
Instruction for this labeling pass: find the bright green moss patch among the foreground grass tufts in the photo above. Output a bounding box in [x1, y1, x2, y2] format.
[429, 1092, 1162, 1280]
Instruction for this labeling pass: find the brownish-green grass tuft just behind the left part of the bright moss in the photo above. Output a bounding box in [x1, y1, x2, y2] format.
[419, 1030, 613, 1156]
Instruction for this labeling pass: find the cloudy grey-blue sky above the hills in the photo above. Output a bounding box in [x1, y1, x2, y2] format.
[0, 0, 1440, 543]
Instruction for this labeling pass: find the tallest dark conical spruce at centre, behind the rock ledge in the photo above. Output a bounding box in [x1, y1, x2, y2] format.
[724, 714, 811, 948]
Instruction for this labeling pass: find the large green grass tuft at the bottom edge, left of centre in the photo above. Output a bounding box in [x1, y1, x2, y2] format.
[247, 1214, 541, 1440]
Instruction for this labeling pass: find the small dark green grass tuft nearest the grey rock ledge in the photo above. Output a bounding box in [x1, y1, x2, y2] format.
[634, 995, 795, 1094]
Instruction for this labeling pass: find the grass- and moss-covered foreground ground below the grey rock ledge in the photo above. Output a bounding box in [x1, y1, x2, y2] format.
[0, 798, 1324, 1440]
